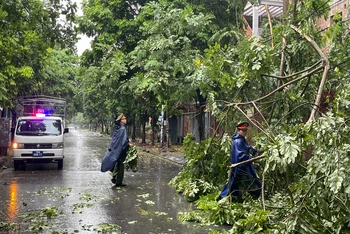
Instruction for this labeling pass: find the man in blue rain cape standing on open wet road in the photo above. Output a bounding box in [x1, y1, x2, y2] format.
[101, 114, 131, 187]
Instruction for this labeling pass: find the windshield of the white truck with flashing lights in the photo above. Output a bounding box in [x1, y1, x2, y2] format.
[16, 119, 62, 136]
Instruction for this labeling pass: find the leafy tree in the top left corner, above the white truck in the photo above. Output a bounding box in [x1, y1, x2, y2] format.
[0, 0, 76, 107]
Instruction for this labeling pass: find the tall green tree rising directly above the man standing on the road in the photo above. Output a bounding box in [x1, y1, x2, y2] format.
[79, 0, 153, 132]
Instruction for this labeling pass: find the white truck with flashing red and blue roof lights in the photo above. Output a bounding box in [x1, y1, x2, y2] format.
[11, 96, 69, 170]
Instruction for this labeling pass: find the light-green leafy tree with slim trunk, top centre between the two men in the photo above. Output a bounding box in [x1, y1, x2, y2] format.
[129, 1, 215, 146]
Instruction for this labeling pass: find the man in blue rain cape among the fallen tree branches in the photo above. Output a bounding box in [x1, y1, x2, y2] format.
[217, 122, 261, 200]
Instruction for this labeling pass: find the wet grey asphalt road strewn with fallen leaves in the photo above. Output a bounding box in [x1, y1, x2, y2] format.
[0, 128, 215, 234]
